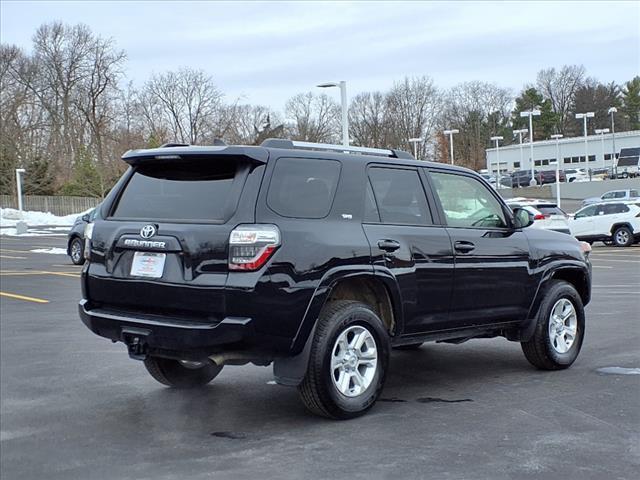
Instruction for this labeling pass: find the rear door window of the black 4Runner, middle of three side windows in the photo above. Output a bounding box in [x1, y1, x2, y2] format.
[369, 167, 433, 225]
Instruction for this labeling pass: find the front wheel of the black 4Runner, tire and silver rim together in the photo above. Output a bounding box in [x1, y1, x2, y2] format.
[521, 280, 584, 370]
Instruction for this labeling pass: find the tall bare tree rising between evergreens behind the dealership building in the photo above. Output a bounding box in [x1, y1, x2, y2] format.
[536, 65, 586, 134]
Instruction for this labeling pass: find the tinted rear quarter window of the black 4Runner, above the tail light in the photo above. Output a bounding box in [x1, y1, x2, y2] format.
[267, 158, 341, 218]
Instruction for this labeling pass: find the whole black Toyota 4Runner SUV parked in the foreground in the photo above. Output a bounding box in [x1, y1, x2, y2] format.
[79, 139, 591, 419]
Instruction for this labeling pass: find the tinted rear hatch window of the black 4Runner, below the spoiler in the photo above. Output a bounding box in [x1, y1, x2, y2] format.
[112, 158, 240, 222]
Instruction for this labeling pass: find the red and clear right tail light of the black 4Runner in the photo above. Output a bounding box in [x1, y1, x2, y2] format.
[229, 225, 280, 271]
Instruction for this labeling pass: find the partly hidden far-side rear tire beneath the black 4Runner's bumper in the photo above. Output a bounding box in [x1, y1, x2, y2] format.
[144, 357, 222, 388]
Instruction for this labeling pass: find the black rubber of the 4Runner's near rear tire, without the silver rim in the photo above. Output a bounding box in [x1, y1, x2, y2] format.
[298, 300, 390, 420]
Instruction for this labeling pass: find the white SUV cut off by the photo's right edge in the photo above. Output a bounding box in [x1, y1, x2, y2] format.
[569, 202, 640, 247]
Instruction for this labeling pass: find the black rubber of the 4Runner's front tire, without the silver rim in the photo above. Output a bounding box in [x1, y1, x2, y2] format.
[521, 280, 585, 370]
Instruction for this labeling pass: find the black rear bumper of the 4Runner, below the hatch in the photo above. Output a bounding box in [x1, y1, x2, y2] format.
[78, 300, 255, 354]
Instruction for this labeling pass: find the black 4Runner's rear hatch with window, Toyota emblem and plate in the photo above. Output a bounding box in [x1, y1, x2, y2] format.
[85, 150, 264, 322]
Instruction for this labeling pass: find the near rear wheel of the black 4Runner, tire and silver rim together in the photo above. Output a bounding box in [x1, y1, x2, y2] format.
[298, 300, 389, 419]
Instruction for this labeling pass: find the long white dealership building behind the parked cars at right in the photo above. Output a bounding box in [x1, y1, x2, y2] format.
[487, 130, 640, 173]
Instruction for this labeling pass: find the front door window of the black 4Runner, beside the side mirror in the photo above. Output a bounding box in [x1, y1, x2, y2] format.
[431, 172, 507, 228]
